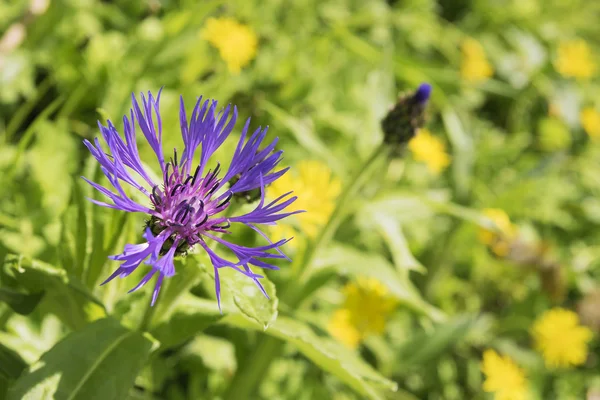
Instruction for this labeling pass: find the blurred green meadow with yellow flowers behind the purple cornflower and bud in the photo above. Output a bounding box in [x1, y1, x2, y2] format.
[0, 0, 600, 400]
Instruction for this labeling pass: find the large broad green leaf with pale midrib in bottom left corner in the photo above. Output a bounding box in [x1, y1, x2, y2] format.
[8, 318, 154, 400]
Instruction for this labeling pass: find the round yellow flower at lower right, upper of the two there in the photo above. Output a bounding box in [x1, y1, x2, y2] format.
[531, 308, 593, 368]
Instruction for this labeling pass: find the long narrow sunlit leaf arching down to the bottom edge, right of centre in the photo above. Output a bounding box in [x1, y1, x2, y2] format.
[223, 314, 397, 399]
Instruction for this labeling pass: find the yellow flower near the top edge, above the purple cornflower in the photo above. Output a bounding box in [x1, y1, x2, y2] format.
[201, 17, 258, 74]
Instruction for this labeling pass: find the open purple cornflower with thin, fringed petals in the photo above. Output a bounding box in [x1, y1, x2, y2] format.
[83, 91, 299, 307]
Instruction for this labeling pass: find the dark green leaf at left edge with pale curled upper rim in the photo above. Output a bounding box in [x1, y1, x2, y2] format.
[0, 255, 106, 329]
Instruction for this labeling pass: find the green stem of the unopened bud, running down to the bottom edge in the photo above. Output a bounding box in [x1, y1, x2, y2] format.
[224, 144, 385, 400]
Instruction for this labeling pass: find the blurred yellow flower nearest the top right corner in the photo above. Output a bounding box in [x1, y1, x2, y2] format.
[554, 39, 596, 78]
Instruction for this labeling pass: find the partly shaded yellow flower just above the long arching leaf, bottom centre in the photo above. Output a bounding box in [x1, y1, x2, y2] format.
[328, 278, 396, 348]
